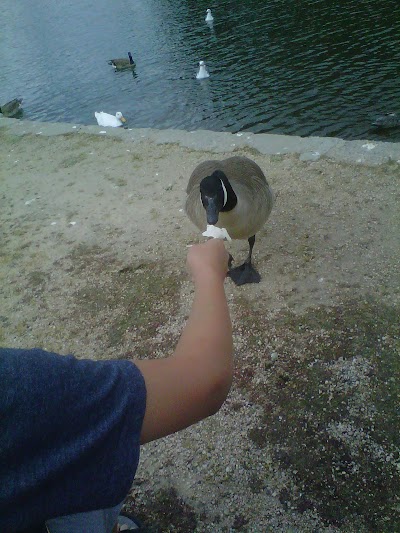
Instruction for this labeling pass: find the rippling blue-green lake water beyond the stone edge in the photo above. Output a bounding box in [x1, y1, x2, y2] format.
[0, 0, 400, 141]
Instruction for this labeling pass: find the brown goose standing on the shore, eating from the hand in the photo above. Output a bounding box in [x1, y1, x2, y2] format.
[185, 156, 275, 285]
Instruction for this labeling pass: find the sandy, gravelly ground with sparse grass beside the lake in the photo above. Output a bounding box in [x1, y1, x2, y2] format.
[0, 122, 400, 533]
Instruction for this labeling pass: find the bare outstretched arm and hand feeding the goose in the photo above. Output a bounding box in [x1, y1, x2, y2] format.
[135, 239, 233, 444]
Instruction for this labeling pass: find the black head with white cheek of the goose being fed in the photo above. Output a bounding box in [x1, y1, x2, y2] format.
[200, 170, 237, 225]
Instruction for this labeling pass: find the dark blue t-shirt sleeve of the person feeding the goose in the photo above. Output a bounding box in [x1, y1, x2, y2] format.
[0, 348, 146, 533]
